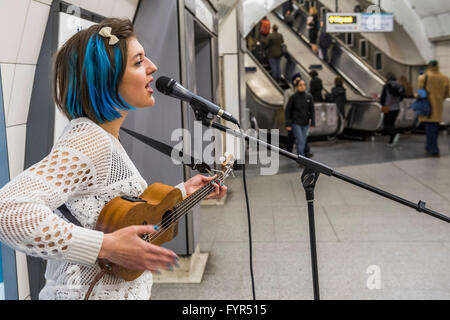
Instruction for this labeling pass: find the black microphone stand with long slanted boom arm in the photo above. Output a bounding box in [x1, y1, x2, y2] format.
[194, 112, 450, 300]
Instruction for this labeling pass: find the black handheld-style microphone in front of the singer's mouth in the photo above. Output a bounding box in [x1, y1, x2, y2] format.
[156, 76, 239, 125]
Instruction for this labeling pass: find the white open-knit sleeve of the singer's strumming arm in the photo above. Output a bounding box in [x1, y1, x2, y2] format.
[0, 122, 111, 265]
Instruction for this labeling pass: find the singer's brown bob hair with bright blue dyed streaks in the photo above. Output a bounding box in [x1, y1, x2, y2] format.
[53, 18, 135, 123]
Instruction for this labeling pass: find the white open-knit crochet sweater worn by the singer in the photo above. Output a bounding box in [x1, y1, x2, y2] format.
[0, 118, 186, 299]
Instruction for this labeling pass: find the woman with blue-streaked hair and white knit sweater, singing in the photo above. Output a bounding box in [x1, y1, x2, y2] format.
[0, 18, 227, 299]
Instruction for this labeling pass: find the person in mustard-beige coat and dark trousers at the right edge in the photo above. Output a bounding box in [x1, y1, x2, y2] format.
[419, 60, 449, 157]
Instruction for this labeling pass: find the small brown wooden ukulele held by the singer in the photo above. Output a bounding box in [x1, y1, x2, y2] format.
[96, 155, 233, 281]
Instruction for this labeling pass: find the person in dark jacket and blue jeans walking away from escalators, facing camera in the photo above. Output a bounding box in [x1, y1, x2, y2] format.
[285, 80, 315, 156]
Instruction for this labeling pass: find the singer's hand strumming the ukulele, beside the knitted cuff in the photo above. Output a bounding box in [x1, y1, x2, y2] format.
[98, 225, 178, 272]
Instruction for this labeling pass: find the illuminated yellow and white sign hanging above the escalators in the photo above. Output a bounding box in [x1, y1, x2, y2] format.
[326, 13, 394, 33]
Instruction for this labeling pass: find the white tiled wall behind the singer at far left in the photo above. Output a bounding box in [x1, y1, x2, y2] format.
[0, 0, 139, 299]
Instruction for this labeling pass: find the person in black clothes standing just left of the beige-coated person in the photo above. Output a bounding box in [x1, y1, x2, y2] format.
[380, 73, 405, 147]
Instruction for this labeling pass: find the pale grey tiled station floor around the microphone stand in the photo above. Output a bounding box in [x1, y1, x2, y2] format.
[152, 132, 450, 299]
